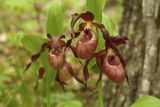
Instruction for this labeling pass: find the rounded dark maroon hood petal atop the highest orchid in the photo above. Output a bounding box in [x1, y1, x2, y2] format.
[81, 11, 94, 22]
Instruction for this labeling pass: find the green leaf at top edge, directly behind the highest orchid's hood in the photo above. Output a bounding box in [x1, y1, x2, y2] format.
[86, 0, 105, 22]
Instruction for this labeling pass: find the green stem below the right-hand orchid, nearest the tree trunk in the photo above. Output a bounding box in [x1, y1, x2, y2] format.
[98, 79, 104, 107]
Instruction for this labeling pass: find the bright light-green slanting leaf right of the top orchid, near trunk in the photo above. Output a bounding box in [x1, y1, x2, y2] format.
[102, 14, 118, 36]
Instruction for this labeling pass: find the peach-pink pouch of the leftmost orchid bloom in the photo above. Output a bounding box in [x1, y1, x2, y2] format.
[48, 49, 65, 69]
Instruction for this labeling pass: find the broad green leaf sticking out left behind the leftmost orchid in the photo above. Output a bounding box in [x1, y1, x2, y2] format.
[22, 34, 48, 54]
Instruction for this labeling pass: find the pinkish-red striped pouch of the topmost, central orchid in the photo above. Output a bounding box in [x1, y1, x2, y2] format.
[76, 32, 98, 59]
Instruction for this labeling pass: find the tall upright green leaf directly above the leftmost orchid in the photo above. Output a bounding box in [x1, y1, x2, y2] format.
[47, 0, 64, 36]
